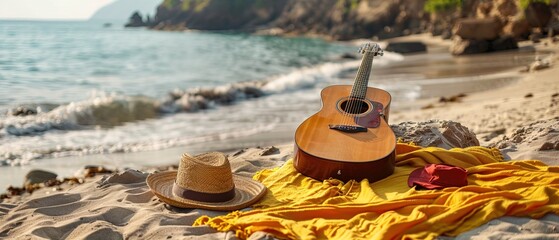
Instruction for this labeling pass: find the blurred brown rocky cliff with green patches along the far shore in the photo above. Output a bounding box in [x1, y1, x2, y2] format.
[150, 0, 559, 40]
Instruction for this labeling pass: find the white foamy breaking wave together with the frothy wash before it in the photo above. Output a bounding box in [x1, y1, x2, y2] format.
[0, 53, 410, 165]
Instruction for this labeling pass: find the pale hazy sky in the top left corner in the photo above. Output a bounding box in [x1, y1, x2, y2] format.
[0, 0, 114, 20]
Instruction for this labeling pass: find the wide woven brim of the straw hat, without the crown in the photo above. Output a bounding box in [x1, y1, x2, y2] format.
[146, 171, 266, 211]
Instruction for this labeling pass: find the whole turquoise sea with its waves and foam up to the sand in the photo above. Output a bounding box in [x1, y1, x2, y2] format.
[0, 21, 544, 176]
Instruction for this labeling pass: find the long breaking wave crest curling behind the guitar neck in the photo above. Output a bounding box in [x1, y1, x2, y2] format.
[0, 53, 401, 137]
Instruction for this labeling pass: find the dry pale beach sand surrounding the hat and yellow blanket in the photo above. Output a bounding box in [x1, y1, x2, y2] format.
[0, 32, 559, 239]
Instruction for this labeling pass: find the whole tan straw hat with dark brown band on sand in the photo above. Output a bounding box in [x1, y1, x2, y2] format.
[146, 152, 266, 211]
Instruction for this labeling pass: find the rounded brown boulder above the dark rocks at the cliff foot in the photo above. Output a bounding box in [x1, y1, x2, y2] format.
[452, 18, 502, 40]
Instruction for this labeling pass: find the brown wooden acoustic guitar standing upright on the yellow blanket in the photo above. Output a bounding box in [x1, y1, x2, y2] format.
[294, 43, 396, 182]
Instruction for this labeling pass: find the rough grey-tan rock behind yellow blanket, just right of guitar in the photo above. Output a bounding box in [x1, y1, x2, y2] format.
[390, 120, 479, 149]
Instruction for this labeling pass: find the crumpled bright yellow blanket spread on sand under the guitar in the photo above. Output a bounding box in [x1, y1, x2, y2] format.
[194, 144, 559, 239]
